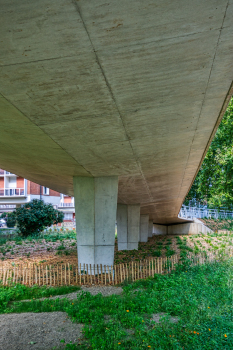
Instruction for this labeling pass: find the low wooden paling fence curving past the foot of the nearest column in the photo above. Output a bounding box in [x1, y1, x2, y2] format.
[0, 254, 229, 286]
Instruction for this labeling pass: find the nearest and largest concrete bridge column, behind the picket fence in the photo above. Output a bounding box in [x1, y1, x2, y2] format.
[73, 176, 118, 266]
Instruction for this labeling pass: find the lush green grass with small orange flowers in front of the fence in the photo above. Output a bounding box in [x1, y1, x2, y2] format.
[0, 259, 233, 350]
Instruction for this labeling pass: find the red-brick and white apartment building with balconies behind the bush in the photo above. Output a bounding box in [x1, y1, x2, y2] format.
[0, 169, 75, 224]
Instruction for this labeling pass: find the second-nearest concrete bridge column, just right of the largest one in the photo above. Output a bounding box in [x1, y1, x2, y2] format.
[117, 204, 140, 250]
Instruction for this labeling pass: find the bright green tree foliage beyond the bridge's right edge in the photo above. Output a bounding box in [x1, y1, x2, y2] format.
[185, 98, 233, 210]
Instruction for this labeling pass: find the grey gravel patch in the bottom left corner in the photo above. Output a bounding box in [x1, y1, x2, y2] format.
[0, 312, 83, 350]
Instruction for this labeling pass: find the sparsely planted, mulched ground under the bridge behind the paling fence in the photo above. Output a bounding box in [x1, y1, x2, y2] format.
[0, 228, 233, 266]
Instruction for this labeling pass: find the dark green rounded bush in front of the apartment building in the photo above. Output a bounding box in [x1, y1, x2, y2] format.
[15, 199, 64, 236]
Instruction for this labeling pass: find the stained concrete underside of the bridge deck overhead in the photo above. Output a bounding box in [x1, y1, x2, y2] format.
[0, 0, 233, 224]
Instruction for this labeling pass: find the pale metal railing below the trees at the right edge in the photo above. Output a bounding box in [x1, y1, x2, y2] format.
[179, 205, 233, 219]
